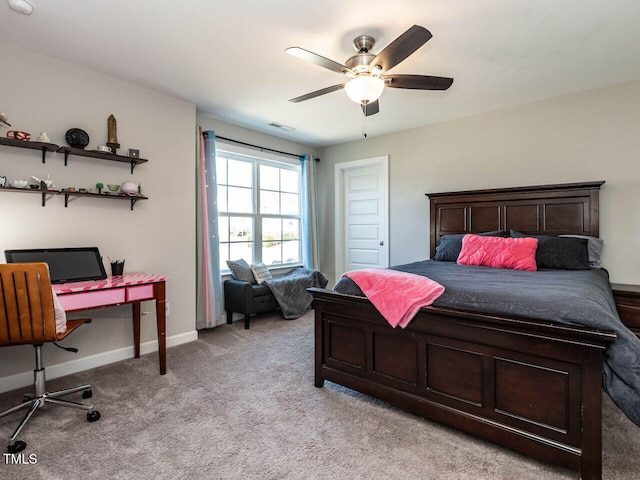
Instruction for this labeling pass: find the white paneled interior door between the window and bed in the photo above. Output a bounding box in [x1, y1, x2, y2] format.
[335, 156, 389, 278]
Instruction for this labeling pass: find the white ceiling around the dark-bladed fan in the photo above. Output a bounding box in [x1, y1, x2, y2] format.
[0, 0, 640, 146]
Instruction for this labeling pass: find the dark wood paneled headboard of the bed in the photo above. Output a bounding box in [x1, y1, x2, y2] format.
[426, 181, 604, 258]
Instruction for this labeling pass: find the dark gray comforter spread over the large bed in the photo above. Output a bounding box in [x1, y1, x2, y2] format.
[334, 260, 640, 426]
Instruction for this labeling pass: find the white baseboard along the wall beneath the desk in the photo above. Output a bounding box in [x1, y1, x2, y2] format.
[0, 330, 198, 393]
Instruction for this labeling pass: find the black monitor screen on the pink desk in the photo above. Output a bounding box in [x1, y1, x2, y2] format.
[4, 247, 107, 283]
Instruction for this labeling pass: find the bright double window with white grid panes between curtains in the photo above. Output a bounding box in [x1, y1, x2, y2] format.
[216, 150, 302, 270]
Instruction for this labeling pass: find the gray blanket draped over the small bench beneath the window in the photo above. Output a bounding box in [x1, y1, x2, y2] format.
[264, 268, 329, 320]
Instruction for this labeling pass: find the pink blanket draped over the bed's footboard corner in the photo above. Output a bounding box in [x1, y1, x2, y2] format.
[343, 268, 444, 328]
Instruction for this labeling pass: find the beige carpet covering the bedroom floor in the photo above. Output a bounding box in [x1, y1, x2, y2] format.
[0, 313, 640, 480]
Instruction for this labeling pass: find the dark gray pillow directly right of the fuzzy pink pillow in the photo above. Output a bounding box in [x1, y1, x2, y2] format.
[511, 230, 590, 270]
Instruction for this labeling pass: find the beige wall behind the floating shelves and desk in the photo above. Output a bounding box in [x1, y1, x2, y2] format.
[0, 42, 197, 391]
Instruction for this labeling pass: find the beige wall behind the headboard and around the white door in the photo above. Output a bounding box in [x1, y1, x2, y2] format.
[318, 82, 640, 284]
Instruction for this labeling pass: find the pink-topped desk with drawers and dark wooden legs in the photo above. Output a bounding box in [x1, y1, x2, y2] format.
[53, 273, 167, 375]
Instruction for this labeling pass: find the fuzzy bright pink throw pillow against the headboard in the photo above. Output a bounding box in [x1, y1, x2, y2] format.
[458, 234, 538, 272]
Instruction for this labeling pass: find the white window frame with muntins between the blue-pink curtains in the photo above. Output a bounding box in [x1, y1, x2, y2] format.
[216, 145, 303, 275]
